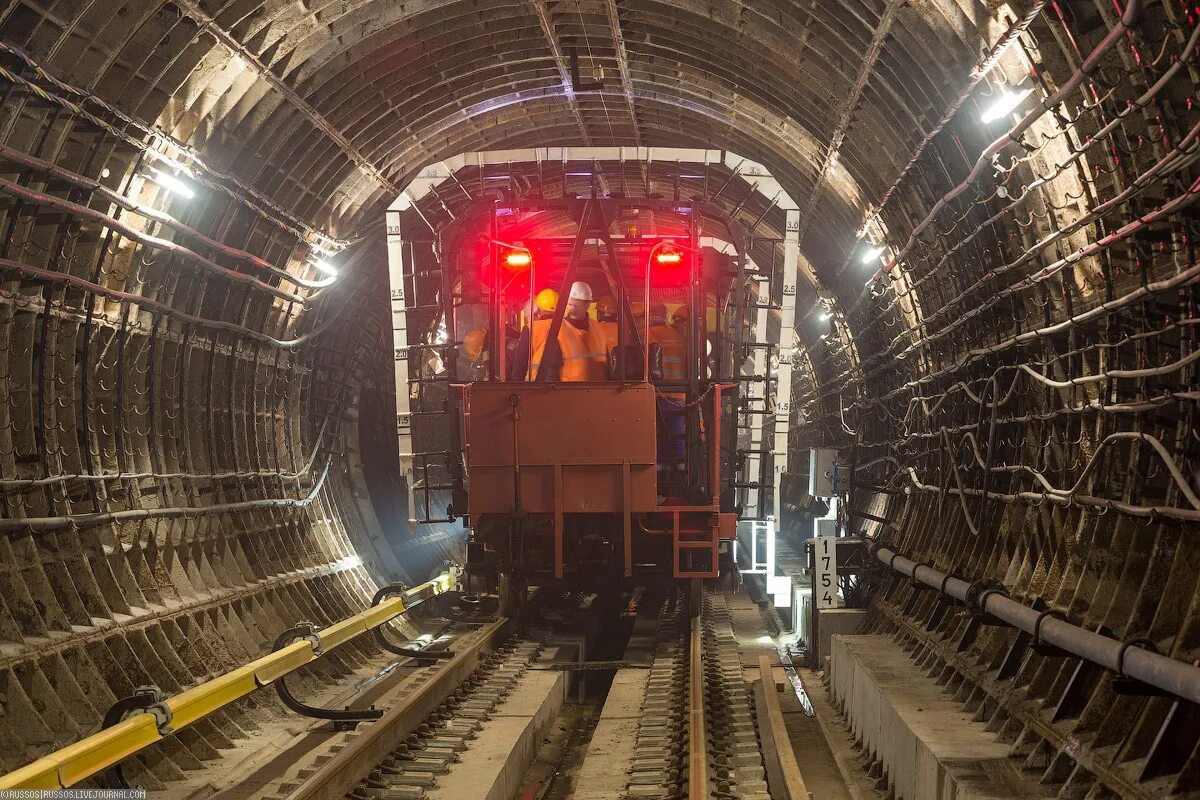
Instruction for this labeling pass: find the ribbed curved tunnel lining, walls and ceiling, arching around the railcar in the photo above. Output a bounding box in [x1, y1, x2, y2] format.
[0, 0, 1200, 798]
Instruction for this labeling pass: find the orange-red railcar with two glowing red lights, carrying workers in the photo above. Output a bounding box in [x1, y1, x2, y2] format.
[448, 199, 740, 606]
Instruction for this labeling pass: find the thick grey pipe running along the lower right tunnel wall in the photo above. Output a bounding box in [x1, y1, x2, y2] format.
[874, 546, 1200, 703]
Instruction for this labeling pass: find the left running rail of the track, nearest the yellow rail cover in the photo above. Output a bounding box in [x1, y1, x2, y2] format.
[279, 618, 511, 800]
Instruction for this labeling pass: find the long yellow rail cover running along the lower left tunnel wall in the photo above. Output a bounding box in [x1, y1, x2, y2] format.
[0, 572, 454, 789]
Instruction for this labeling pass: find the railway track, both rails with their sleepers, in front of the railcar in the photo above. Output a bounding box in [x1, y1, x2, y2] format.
[274, 593, 788, 800]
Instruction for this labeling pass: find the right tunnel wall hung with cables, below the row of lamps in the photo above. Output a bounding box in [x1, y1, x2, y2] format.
[794, 4, 1200, 798]
